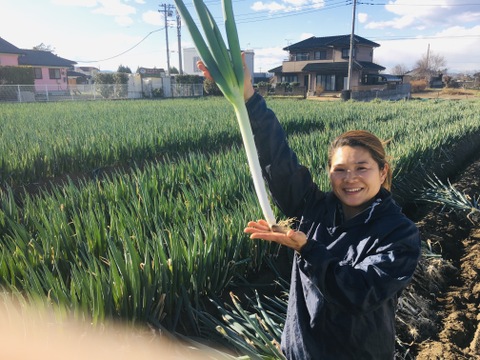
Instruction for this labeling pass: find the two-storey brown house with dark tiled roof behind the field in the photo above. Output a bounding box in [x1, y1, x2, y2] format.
[270, 35, 385, 94]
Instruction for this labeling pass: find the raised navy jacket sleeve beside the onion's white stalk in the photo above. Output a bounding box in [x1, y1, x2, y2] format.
[246, 93, 323, 219]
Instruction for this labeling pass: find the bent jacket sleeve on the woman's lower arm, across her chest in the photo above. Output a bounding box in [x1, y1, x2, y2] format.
[296, 218, 421, 313]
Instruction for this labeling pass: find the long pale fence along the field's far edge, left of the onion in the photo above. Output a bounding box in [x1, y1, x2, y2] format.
[0, 84, 203, 102]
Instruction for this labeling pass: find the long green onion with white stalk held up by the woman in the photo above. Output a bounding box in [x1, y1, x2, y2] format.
[175, 0, 276, 226]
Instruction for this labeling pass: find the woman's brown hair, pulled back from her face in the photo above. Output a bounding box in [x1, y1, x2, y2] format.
[328, 130, 392, 190]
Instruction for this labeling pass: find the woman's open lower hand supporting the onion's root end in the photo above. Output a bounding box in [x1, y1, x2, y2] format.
[244, 220, 307, 251]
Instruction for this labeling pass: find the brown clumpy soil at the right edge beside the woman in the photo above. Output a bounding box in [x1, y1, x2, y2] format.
[400, 158, 480, 360]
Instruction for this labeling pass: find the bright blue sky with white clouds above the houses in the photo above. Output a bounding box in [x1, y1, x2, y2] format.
[0, 0, 480, 74]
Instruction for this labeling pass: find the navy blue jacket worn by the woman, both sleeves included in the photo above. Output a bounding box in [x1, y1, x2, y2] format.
[247, 94, 421, 360]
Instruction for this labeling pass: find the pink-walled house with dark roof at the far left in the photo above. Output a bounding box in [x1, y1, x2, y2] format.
[0, 38, 76, 92]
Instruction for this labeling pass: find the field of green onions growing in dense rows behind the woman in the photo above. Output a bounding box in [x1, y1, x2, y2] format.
[0, 98, 480, 358]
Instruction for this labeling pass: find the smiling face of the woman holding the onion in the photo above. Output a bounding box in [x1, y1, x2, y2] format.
[329, 146, 388, 219]
